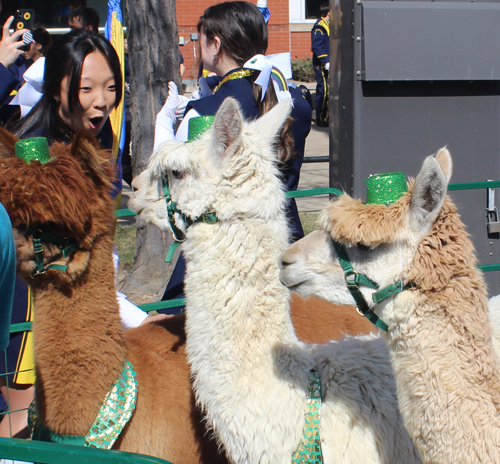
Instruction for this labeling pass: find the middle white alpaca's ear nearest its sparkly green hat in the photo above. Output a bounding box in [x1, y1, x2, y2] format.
[212, 97, 243, 161]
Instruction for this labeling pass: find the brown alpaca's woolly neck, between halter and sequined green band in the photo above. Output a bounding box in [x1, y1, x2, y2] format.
[33, 237, 126, 435]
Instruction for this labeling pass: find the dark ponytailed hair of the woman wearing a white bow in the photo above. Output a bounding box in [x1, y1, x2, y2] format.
[197, 1, 293, 161]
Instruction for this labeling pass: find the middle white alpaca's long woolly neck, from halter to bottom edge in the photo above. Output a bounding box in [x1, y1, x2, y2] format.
[184, 218, 312, 464]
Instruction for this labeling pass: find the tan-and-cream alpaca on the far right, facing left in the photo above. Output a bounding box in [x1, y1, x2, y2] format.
[281, 149, 500, 464]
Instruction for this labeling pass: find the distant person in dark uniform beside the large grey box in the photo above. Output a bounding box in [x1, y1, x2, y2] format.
[311, 3, 330, 127]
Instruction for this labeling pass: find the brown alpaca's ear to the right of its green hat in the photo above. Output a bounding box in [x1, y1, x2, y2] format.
[71, 130, 112, 185]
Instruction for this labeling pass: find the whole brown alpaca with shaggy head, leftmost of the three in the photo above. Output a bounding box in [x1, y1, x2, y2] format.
[0, 129, 370, 464]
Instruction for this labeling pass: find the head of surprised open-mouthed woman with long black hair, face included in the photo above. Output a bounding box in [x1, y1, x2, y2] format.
[13, 30, 123, 148]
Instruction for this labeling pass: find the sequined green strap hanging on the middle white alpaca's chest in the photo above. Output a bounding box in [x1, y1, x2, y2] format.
[292, 369, 323, 464]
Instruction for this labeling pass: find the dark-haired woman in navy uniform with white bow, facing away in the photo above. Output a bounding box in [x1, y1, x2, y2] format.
[155, 1, 311, 306]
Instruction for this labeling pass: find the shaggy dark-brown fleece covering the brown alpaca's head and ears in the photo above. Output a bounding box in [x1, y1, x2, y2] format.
[0, 131, 113, 250]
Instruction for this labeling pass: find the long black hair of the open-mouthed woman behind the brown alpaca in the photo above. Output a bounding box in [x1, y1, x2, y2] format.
[12, 29, 123, 141]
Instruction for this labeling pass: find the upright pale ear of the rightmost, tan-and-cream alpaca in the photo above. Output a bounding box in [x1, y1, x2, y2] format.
[410, 148, 452, 234]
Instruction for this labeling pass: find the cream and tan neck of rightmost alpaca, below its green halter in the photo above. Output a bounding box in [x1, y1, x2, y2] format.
[384, 284, 500, 463]
